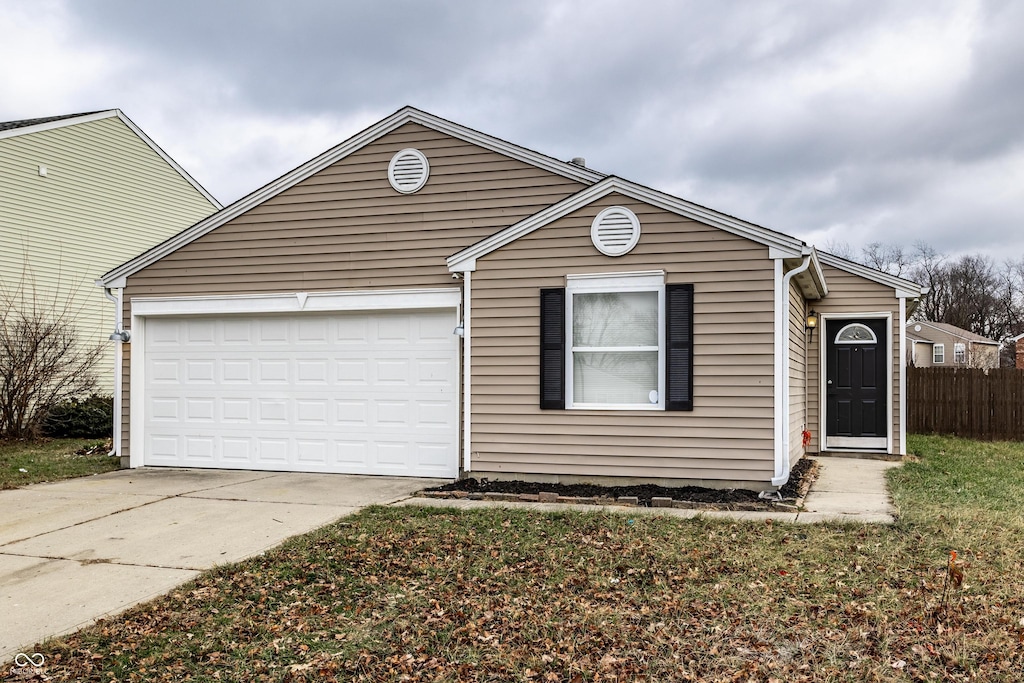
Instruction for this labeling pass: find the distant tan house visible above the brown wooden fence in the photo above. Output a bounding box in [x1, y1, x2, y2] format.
[906, 321, 999, 369]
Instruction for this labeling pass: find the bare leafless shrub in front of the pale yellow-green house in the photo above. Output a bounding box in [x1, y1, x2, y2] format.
[0, 276, 103, 438]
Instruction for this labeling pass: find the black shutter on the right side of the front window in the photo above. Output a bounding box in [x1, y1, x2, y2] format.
[665, 285, 693, 411]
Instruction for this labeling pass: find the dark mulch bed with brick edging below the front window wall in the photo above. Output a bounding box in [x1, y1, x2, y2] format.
[422, 458, 817, 510]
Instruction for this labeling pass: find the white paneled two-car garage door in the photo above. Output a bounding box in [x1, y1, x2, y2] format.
[143, 310, 458, 477]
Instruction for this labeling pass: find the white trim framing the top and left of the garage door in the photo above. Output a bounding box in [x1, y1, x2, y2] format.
[128, 288, 462, 468]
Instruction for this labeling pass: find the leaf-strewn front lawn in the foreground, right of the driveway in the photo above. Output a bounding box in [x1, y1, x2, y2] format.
[8, 437, 1024, 682]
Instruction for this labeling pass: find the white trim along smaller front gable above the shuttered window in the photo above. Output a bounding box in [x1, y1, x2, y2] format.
[447, 176, 807, 272]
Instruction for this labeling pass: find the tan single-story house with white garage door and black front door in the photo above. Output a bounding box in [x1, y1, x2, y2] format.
[102, 108, 921, 488]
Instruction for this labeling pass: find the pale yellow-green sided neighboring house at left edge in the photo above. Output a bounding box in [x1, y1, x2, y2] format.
[0, 110, 221, 392]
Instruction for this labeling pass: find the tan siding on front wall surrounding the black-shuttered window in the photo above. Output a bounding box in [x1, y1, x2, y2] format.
[471, 195, 774, 483]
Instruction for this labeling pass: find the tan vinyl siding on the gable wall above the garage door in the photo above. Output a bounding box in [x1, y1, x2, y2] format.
[123, 124, 584, 454]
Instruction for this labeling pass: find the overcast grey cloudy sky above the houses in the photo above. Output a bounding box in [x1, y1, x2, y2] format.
[0, 0, 1024, 258]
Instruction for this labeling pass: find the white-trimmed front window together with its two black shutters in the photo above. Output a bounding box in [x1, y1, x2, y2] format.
[540, 271, 693, 411]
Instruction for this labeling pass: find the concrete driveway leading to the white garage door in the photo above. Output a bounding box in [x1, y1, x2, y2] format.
[0, 468, 441, 661]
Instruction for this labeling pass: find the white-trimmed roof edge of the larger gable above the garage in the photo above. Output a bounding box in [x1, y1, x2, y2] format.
[97, 106, 605, 287]
